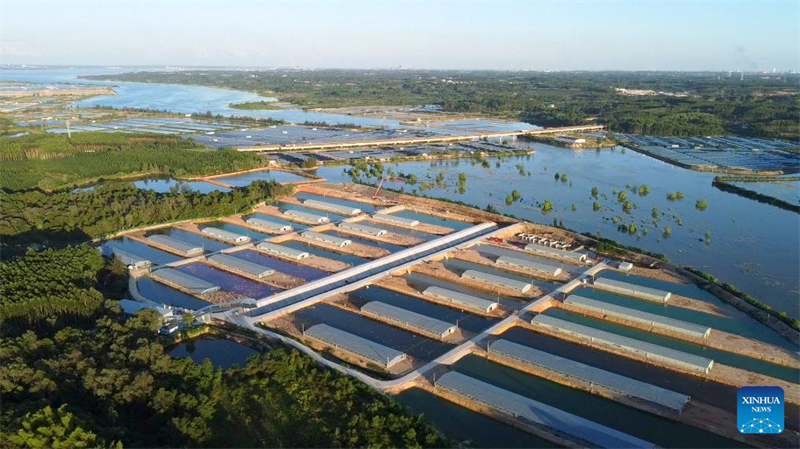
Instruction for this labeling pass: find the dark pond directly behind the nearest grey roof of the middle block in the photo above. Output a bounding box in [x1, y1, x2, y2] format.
[293, 304, 452, 360]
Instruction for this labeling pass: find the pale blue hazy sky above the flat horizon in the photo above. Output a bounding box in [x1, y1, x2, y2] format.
[0, 0, 800, 71]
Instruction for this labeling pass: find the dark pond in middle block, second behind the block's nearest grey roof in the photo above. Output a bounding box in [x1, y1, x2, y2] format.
[349, 287, 498, 332]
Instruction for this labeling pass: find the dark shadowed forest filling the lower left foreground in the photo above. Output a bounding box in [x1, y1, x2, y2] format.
[0, 246, 448, 448]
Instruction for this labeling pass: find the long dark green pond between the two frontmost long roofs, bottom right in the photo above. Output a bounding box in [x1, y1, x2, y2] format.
[453, 355, 746, 448]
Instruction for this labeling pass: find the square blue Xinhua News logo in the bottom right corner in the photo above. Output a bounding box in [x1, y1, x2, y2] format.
[736, 387, 783, 433]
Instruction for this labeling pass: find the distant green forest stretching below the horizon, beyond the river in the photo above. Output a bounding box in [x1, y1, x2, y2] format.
[87, 70, 800, 140]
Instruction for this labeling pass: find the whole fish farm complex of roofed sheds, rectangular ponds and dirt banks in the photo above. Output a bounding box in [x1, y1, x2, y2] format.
[101, 176, 800, 448]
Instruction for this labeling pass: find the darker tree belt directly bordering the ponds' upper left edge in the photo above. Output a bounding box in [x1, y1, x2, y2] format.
[0, 181, 292, 252]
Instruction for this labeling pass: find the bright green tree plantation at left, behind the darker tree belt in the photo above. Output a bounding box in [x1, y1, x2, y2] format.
[0, 132, 265, 190]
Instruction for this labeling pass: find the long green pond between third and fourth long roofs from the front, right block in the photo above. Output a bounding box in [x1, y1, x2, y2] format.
[543, 308, 800, 383]
